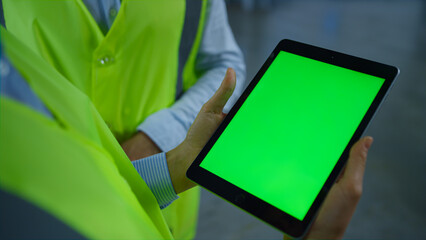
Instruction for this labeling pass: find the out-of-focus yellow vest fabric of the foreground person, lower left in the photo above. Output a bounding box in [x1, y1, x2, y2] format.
[0, 28, 173, 239]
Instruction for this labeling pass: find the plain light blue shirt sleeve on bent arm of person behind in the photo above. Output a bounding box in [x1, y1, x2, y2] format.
[138, 0, 246, 152]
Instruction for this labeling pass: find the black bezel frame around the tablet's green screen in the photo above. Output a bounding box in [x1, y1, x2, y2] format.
[187, 39, 399, 237]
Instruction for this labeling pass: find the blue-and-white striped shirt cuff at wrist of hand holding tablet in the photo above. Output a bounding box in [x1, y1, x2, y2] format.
[132, 152, 179, 209]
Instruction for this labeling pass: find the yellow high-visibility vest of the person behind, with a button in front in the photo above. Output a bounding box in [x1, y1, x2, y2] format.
[3, 0, 207, 239]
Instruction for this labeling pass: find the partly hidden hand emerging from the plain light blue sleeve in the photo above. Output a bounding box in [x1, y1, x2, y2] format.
[121, 132, 161, 161]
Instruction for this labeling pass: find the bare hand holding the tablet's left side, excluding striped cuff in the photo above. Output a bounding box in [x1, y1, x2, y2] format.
[166, 68, 236, 193]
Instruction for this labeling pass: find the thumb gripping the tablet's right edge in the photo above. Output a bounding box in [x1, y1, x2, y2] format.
[341, 137, 373, 184]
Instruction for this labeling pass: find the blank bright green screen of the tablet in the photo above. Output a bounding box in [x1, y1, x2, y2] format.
[200, 51, 384, 220]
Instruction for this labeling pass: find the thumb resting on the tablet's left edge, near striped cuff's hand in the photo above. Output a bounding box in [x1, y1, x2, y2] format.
[203, 68, 236, 113]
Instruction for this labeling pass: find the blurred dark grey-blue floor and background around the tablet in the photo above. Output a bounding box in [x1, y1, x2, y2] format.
[196, 0, 426, 239]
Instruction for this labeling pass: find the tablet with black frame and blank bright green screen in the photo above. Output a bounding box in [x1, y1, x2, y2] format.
[187, 40, 399, 237]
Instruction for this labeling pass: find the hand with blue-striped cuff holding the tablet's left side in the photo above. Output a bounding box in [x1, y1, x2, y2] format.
[126, 69, 236, 208]
